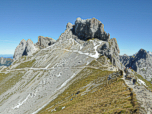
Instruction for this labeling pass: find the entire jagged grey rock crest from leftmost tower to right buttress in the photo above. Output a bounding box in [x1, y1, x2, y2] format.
[14, 17, 123, 69]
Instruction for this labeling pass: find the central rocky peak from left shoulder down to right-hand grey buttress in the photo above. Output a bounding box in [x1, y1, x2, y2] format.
[57, 17, 123, 69]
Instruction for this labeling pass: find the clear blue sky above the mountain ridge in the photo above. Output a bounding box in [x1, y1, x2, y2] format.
[0, 0, 152, 55]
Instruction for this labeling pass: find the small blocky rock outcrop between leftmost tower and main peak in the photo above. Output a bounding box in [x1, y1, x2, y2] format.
[36, 36, 56, 49]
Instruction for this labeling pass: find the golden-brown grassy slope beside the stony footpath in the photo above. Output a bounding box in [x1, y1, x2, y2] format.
[38, 63, 140, 114]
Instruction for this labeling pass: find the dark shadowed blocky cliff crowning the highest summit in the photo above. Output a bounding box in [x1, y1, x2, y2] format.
[74, 18, 110, 41]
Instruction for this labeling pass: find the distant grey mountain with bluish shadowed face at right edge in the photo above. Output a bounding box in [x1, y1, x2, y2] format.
[120, 49, 152, 81]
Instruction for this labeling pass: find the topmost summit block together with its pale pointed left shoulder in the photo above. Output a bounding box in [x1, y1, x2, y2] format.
[58, 17, 110, 41]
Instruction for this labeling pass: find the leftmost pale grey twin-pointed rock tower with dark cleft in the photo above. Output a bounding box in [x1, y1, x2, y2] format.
[13, 39, 37, 60]
